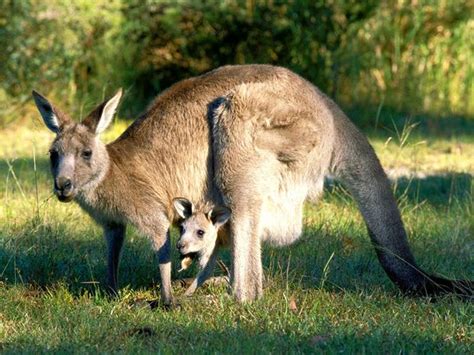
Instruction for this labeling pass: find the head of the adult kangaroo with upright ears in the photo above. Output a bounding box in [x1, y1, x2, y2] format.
[33, 90, 122, 202]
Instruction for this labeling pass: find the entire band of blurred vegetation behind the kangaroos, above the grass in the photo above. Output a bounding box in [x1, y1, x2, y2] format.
[0, 0, 474, 126]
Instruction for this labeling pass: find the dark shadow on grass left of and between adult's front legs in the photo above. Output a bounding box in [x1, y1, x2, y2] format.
[0, 221, 158, 294]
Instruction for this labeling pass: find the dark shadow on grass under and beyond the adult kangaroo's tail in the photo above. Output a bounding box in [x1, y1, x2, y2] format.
[262, 220, 474, 294]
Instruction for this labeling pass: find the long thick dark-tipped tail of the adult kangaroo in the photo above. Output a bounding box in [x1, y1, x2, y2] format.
[331, 105, 474, 299]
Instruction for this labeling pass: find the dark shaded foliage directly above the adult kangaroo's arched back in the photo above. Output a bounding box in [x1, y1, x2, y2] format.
[113, 0, 376, 112]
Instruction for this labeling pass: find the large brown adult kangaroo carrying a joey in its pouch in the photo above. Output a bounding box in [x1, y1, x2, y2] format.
[33, 65, 473, 304]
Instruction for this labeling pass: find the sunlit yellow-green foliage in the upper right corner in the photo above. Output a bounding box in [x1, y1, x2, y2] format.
[347, 1, 474, 115]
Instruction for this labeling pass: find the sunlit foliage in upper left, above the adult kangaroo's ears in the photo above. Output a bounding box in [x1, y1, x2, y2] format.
[0, 0, 121, 120]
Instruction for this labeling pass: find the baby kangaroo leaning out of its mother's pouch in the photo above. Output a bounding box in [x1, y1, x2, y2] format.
[173, 197, 231, 296]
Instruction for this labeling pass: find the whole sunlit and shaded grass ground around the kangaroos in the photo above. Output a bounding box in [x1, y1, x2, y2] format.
[0, 116, 474, 354]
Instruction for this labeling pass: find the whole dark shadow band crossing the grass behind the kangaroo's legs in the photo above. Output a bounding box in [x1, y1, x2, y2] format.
[0, 197, 472, 296]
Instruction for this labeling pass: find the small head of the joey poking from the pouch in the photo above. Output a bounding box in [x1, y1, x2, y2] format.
[173, 198, 230, 263]
